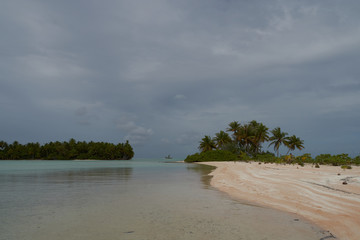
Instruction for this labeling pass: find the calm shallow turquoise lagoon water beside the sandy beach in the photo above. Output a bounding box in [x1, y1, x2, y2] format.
[0, 159, 325, 240]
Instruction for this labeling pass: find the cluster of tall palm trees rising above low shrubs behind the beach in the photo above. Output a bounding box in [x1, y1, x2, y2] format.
[199, 120, 304, 157]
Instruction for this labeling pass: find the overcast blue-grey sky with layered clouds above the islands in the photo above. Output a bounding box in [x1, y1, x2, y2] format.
[0, 0, 360, 158]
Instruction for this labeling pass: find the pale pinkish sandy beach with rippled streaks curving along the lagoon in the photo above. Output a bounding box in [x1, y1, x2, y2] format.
[203, 162, 360, 240]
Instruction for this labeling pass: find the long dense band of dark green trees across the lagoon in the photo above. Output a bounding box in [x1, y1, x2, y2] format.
[0, 139, 134, 160]
